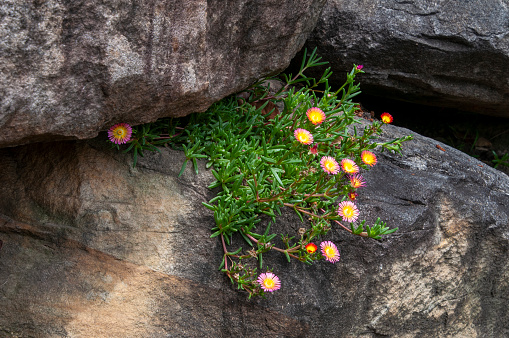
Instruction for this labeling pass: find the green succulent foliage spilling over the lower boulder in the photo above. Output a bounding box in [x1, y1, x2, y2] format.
[108, 51, 411, 297]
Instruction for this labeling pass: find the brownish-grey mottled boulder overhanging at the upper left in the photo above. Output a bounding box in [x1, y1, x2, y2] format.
[0, 0, 325, 147]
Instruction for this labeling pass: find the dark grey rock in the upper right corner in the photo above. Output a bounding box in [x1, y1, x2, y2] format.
[298, 0, 509, 117]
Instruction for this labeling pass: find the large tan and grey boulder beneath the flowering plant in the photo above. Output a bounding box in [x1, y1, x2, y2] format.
[0, 126, 509, 337]
